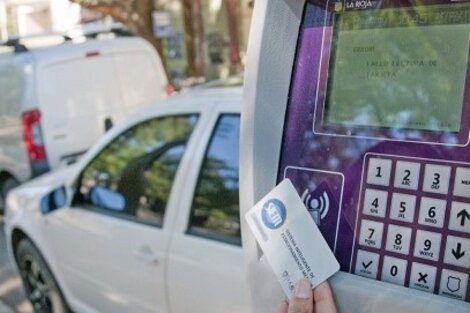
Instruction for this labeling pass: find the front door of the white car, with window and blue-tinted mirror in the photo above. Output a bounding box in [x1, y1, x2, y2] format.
[44, 114, 204, 313]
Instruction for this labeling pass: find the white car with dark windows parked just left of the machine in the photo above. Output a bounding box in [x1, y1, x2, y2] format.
[5, 83, 249, 313]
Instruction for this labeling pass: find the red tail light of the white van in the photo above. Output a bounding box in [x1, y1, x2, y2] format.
[22, 110, 46, 161]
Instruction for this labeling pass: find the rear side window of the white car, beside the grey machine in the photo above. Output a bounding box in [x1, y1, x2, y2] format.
[188, 115, 241, 245]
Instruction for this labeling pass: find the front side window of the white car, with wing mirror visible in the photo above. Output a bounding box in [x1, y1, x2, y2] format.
[77, 115, 197, 226]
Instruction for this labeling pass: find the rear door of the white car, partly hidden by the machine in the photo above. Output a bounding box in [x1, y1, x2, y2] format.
[168, 111, 249, 313]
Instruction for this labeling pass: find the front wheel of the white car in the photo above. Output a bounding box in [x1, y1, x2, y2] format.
[16, 239, 69, 313]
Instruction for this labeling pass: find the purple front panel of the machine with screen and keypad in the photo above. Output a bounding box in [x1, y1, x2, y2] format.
[278, 0, 470, 302]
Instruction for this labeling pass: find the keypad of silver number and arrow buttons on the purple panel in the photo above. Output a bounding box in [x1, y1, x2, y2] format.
[352, 154, 470, 302]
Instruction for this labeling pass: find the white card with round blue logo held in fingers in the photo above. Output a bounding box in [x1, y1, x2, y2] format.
[245, 179, 339, 297]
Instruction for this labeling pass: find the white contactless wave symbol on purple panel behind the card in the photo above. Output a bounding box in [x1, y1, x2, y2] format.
[301, 182, 338, 226]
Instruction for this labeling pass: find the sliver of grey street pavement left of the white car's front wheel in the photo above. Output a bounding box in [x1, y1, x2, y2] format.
[0, 216, 33, 313]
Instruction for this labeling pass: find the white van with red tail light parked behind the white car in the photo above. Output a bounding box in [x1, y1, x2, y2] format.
[0, 37, 168, 211]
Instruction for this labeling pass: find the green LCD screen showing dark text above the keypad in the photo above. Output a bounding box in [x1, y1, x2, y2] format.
[324, 5, 470, 132]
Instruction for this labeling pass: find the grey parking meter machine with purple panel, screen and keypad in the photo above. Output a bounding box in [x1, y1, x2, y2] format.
[240, 0, 470, 313]
